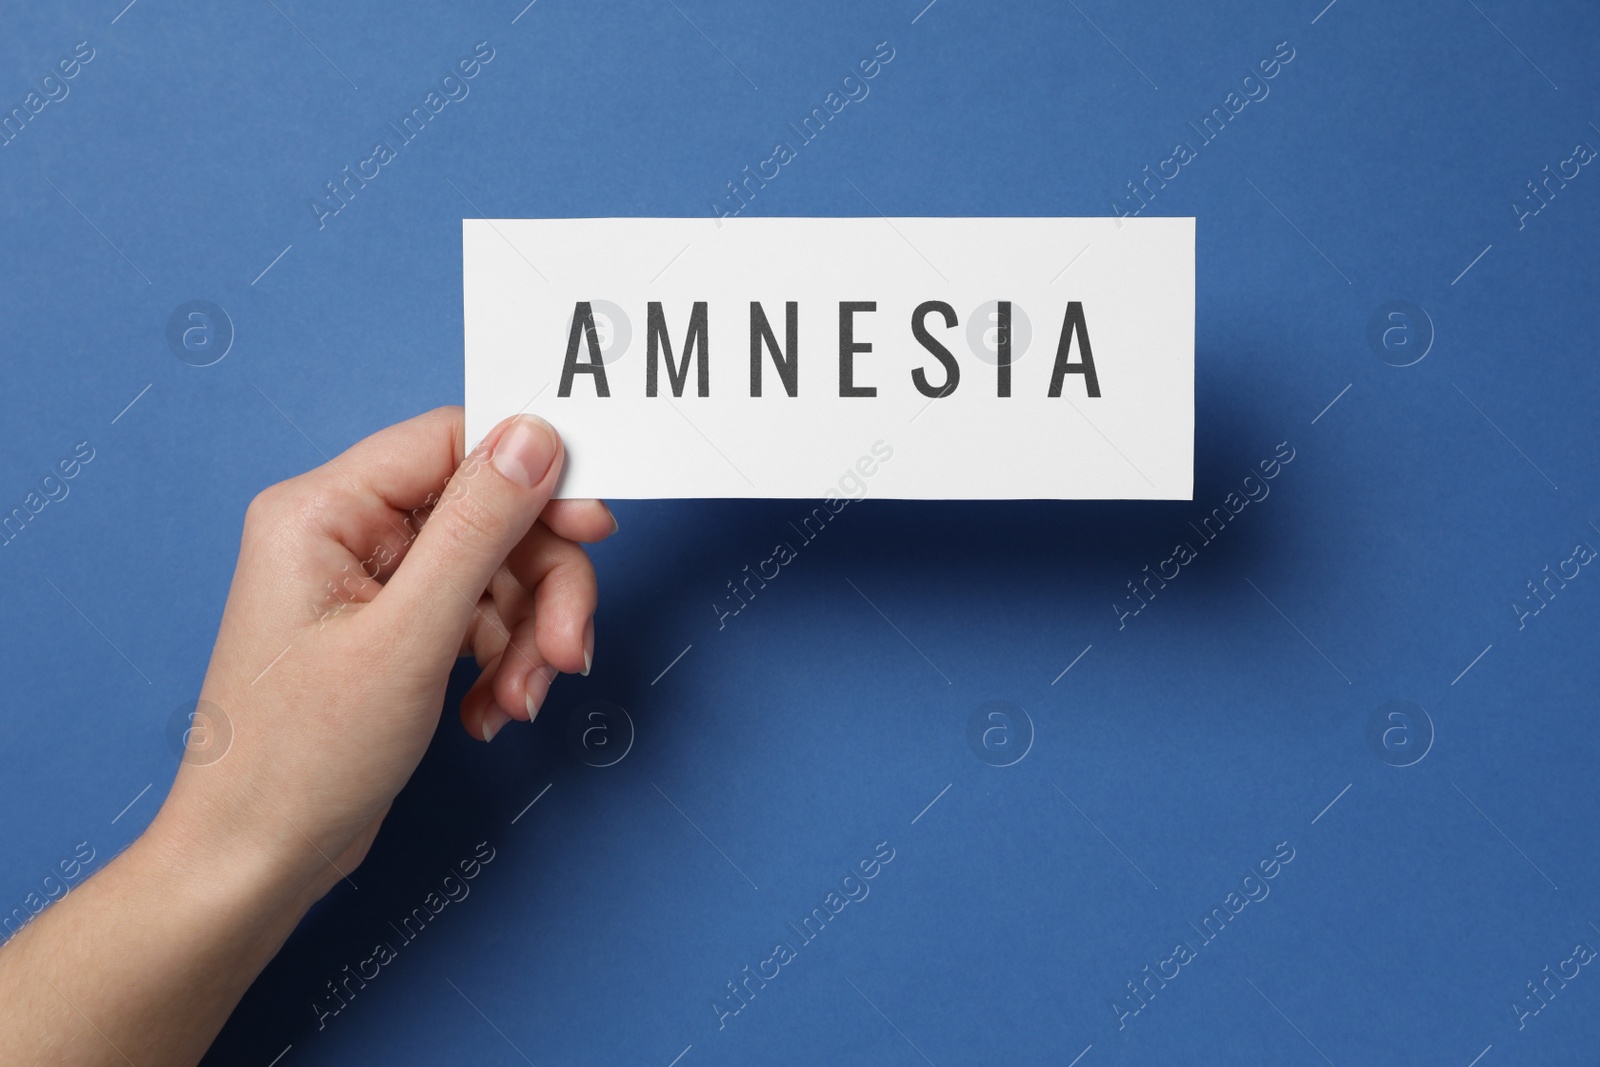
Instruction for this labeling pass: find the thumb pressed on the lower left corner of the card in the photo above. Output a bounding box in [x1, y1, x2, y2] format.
[374, 414, 565, 661]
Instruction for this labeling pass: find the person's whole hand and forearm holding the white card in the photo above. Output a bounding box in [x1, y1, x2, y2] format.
[0, 408, 616, 1064]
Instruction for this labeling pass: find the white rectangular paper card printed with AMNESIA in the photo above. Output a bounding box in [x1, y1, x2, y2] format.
[462, 218, 1195, 499]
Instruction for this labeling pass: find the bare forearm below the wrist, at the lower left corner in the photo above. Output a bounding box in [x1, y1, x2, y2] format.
[0, 817, 315, 1067]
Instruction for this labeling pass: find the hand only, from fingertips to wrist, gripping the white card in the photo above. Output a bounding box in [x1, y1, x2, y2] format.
[152, 408, 616, 901]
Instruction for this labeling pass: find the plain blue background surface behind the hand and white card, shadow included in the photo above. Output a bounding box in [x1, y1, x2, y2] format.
[0, 0, 1600, 1067]
